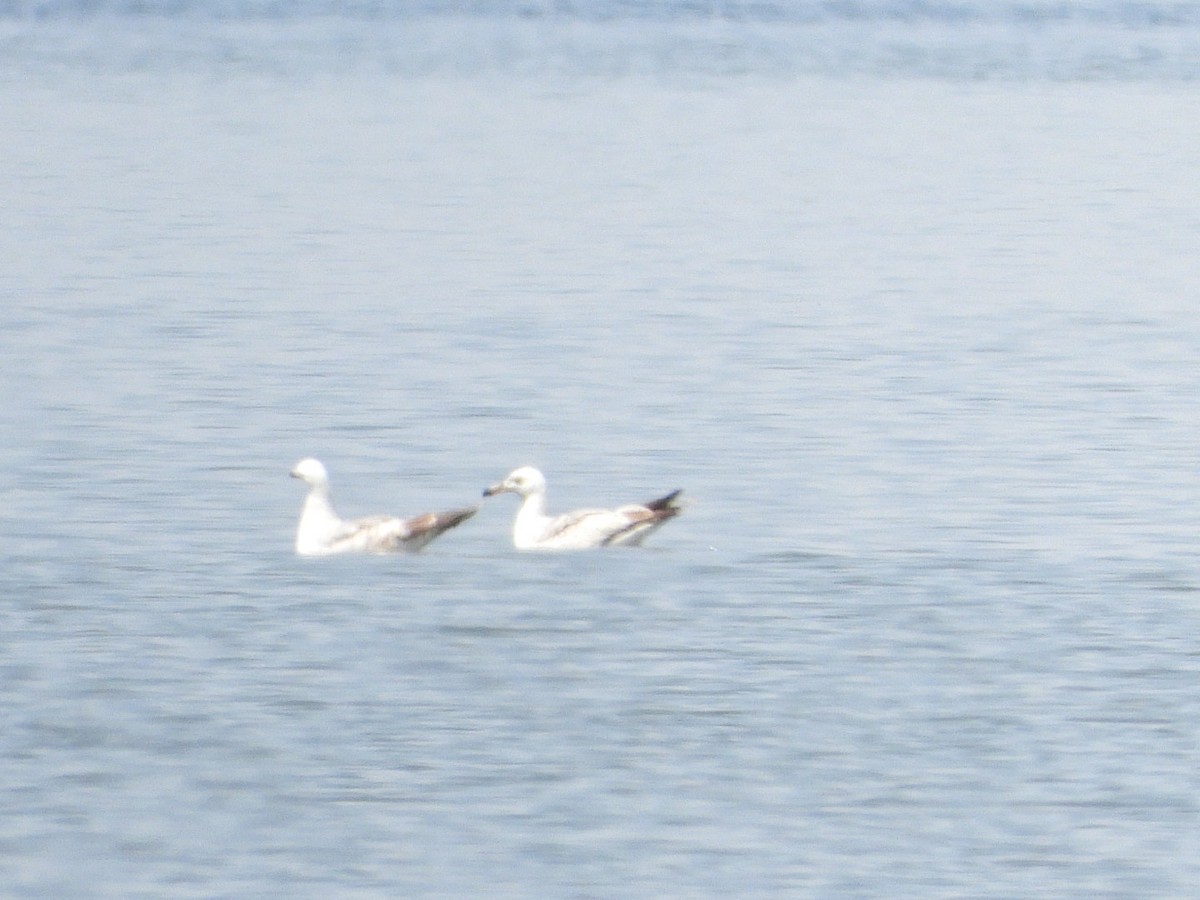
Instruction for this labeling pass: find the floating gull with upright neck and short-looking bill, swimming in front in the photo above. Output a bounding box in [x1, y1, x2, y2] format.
[292, 457, 479, 556]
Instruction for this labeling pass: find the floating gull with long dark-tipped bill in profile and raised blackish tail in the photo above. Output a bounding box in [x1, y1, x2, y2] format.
[484, 466, 683, 550]
